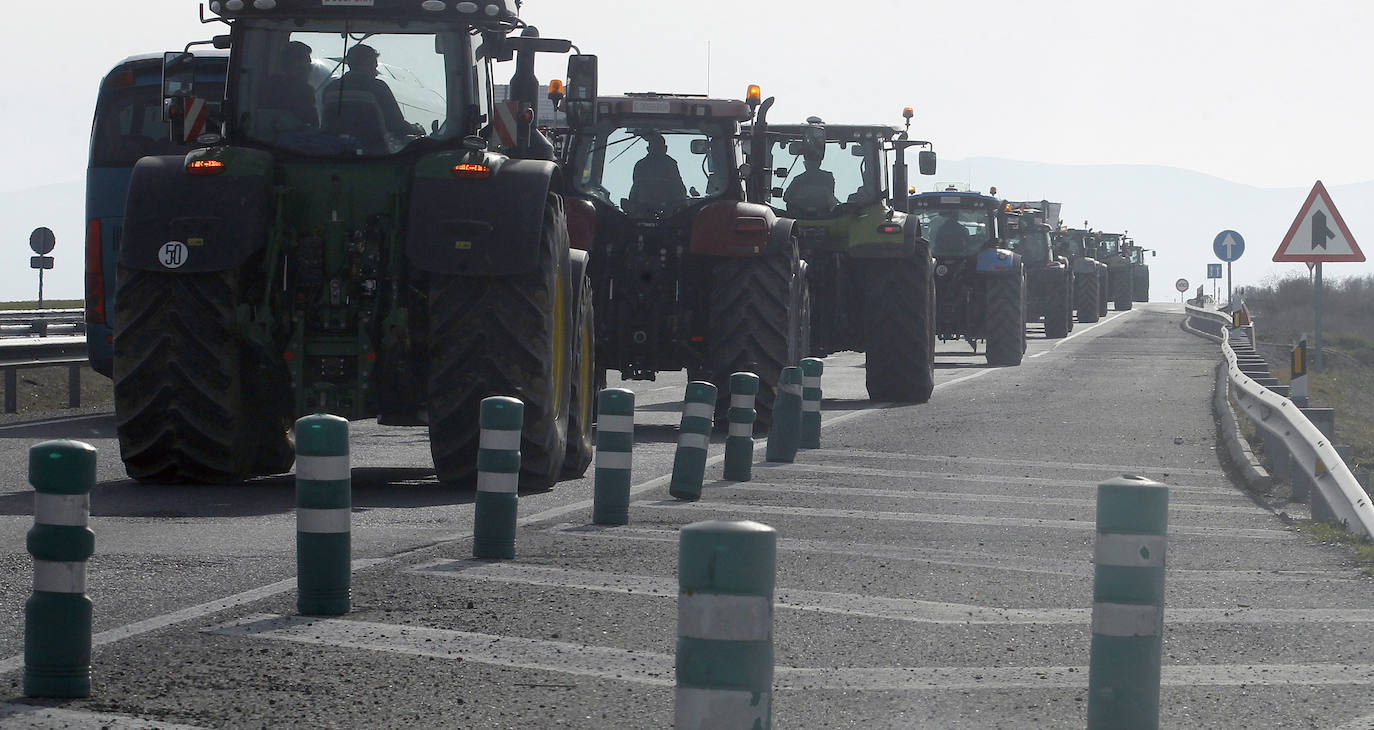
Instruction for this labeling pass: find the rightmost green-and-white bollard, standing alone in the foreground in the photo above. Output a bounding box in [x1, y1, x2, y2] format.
[1088, 476, 1169, 730]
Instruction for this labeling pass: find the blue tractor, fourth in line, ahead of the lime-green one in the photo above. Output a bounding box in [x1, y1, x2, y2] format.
[911, 186, 1026, 366]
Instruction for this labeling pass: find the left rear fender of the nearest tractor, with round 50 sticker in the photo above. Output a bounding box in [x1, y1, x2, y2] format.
[120, 148, 272, 274]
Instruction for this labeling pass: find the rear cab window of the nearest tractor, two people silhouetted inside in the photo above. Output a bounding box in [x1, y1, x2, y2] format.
[234, 23, 475, 157]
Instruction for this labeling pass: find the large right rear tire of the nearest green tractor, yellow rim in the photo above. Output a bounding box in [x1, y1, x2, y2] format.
[429, 195, 573, 489]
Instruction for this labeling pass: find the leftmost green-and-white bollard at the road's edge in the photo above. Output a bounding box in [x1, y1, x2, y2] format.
[23, 441, 95, 697]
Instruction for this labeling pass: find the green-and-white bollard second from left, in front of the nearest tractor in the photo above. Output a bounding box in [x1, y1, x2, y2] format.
[295, 414, 353, 616]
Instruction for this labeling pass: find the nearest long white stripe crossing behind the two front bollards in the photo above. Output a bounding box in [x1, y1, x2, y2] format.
[212, 615, 1374, 692]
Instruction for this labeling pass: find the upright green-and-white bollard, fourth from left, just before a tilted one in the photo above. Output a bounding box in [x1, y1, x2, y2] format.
[592, 388, 635, 525]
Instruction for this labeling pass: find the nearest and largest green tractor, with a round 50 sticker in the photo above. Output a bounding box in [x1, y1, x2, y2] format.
[114, 0, 596, 488]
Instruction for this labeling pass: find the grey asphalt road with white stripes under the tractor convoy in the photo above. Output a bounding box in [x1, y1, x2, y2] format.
[0, 304, 1374, 730]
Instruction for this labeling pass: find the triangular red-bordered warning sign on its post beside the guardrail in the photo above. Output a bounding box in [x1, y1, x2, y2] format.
[1274, 180, 1364, 370]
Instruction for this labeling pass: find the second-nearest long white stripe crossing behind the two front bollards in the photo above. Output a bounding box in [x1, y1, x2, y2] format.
[407, 560, 1374, 630]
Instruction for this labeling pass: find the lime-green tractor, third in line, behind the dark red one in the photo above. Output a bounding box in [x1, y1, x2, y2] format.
[763, 109, 936, 403]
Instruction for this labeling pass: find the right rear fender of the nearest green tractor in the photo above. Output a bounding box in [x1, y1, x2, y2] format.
[405, 151, 558, 276]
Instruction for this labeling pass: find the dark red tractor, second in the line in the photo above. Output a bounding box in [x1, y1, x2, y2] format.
[551, 87, 807, 428]
